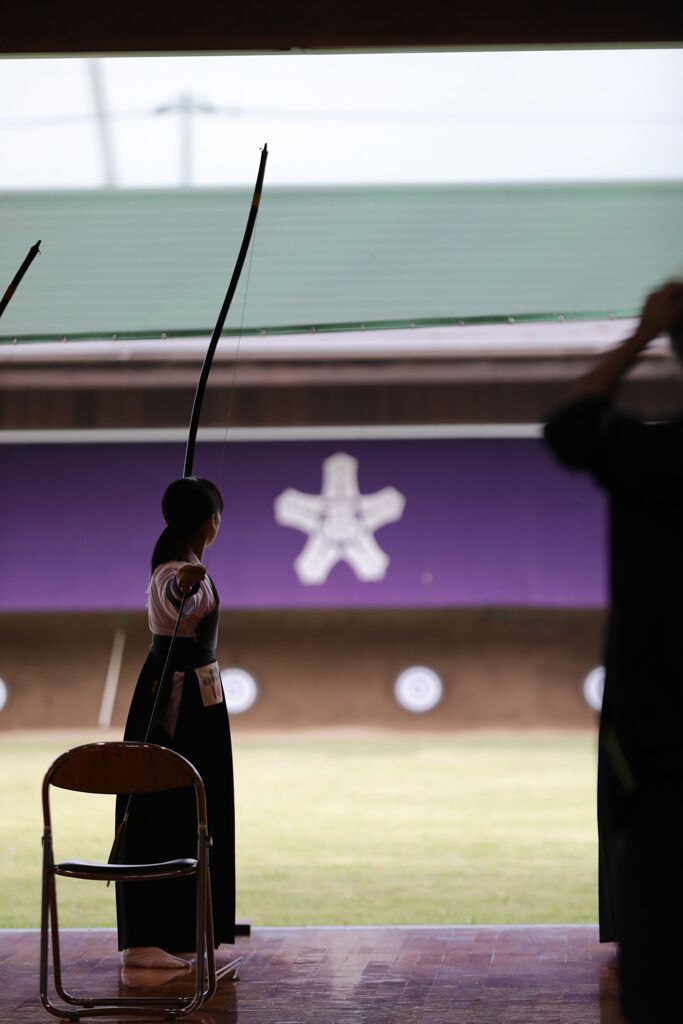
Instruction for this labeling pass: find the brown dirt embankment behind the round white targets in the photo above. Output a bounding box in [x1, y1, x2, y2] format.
[0, 609, 602, 730]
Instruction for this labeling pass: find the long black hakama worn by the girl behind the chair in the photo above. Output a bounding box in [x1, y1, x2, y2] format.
[117, 589, 234, 952]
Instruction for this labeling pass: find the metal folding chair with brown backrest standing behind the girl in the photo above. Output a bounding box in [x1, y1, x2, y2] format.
[40, 742, 222, 1021]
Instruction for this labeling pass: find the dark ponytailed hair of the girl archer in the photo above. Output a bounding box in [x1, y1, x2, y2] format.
[152, 476, 223, 572]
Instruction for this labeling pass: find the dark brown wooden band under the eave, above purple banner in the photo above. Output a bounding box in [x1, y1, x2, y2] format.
[0, 377, 682, 430]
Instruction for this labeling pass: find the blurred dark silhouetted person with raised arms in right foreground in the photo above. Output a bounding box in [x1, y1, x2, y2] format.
[546, 283, 683, 1024]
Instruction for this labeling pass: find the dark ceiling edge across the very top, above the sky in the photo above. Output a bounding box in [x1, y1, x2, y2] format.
[0, 0, 683, 55]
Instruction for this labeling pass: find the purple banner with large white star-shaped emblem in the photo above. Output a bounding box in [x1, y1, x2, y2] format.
[0, 439, 605, 611]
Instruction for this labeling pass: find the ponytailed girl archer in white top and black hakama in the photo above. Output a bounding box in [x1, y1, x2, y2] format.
[116, 476, 234, 970]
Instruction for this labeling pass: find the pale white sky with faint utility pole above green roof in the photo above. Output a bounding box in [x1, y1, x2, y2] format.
[0, 49, 683, 189]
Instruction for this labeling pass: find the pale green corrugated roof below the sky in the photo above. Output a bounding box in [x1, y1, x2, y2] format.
[0, 182, 683, 338]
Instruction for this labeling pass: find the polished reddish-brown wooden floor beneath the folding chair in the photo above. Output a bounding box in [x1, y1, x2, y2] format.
[0, 926, 623, 1024]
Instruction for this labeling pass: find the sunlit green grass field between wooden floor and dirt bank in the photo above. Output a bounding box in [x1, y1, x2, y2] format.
[0, 733, 597, 928]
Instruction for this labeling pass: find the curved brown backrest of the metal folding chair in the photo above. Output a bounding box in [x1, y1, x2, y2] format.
[43, 741, 206, 823]
